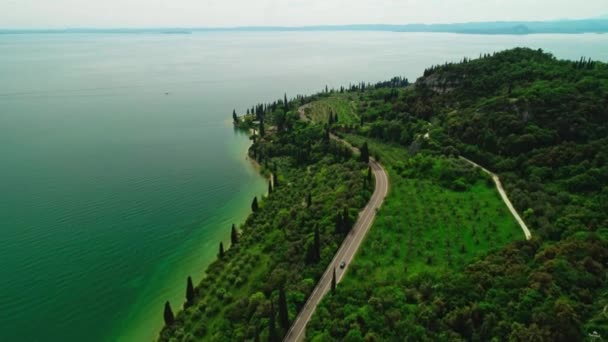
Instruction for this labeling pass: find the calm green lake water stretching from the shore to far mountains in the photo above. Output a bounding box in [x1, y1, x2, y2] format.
[0, 32, 608, 341]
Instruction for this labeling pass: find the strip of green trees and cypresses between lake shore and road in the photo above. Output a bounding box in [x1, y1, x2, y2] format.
[159, 89, 374, 341]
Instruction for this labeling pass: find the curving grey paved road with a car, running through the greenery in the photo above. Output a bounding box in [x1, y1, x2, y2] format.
[283, 135, 388, 341]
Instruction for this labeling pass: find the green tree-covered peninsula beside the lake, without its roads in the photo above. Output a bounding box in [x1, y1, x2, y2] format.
[159, 48, 608, 341]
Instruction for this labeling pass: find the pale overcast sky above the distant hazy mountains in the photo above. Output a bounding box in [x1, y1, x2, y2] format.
[0, 0, 608, 28]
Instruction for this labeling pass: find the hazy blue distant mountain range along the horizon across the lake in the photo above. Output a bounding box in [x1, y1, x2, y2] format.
[0, 17, 608, 34]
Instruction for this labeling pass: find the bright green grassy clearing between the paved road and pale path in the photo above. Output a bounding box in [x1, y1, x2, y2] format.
[345, 135, 523, 281]
